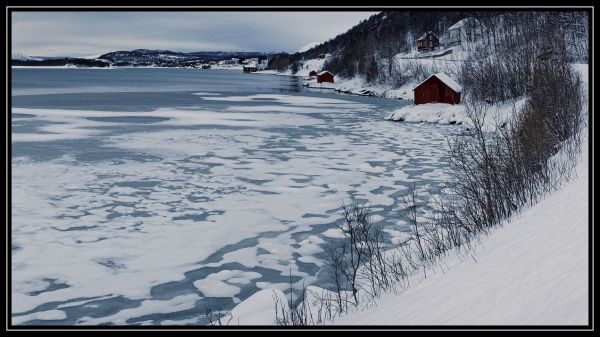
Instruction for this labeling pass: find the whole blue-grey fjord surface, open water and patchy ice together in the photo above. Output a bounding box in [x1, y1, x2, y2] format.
[11, 69, 451, 324]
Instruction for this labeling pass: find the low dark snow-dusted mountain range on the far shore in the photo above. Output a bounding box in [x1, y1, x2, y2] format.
[11, 49, 272, 67]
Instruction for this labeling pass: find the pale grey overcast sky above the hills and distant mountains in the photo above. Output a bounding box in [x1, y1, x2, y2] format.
[12, 12, 376, 57]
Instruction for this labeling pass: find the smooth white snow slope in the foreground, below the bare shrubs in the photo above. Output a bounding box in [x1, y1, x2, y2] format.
[336, 140, 589, 325]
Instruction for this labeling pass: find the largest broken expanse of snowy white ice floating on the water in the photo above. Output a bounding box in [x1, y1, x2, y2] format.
[12, 95, 452, 324]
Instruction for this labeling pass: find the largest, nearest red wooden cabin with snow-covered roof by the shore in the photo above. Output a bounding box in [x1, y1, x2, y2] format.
[413, 73, 462, 105]
